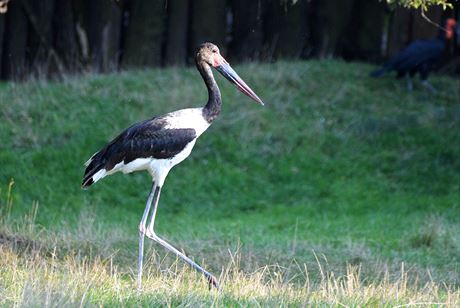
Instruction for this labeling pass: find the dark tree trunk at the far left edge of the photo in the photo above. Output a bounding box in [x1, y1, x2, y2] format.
[2, 0, 28, 80]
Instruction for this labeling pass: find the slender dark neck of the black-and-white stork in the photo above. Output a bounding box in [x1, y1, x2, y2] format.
[196, 61, 222, 123]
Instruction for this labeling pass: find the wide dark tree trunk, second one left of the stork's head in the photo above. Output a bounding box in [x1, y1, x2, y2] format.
[122, 0, 166, 67]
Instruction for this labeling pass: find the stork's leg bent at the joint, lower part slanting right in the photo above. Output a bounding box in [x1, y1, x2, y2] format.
[146, 186, 219, 289]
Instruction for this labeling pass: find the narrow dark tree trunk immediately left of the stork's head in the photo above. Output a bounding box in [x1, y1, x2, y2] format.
[164, 0, 189, 66]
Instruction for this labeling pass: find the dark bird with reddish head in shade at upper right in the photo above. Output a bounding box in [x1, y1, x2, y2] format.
[370, 18, 459, 92]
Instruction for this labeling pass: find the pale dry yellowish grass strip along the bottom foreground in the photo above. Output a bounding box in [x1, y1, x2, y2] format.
[0, 224, 460, 307]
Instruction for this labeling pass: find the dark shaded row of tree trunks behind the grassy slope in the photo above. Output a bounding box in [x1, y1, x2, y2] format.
[0, 0, 460, 80]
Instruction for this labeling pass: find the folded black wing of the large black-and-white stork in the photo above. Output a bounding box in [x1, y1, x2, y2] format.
[82, 117, 196, 187]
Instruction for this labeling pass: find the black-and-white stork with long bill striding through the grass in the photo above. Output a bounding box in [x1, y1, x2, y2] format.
[82, 43, 264, 289]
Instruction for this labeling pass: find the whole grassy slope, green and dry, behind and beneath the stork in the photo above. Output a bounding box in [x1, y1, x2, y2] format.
[0, 60, 460, 307]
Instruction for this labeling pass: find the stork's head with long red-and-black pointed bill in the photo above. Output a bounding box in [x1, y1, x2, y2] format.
[196, 43, 264, 105]
